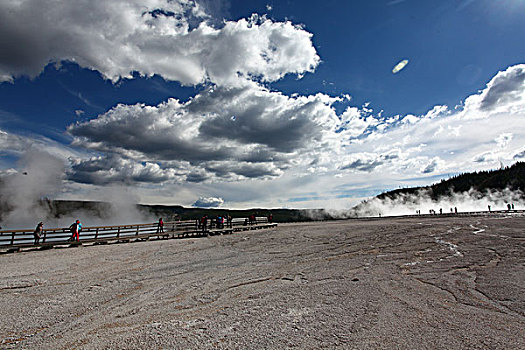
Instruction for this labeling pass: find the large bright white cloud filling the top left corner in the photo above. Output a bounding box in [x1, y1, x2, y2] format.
[0, 0, 319, 85]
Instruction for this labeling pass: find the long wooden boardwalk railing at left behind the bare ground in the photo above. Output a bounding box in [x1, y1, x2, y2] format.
[0, 217, 277, 250]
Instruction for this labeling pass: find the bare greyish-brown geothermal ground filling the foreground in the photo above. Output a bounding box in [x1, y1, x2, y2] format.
[0, 216, 525, 349]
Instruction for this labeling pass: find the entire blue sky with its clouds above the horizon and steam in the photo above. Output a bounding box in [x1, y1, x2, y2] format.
[0, 0, 525, 208]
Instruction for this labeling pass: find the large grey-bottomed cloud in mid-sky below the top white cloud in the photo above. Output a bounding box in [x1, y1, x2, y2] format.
[68, 83, 334, 186]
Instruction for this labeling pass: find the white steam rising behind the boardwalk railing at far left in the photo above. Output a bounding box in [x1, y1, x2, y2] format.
[0, 149, 155, 229]
